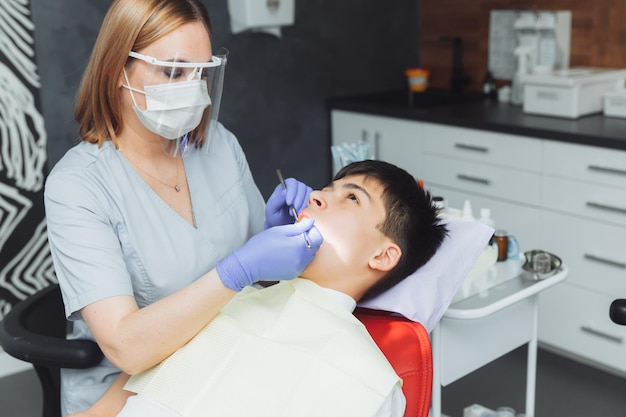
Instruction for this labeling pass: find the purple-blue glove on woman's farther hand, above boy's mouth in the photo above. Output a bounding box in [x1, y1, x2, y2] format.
[265, 178, 312, 229]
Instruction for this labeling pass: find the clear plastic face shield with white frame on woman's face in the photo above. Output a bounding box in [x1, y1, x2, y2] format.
[124, 49, 228, 156]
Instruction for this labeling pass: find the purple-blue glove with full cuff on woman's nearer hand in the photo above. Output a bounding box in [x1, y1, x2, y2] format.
[217, 219, 322, 291]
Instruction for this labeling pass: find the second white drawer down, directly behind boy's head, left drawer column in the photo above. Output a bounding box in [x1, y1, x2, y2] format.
[423, 155, 541, 205]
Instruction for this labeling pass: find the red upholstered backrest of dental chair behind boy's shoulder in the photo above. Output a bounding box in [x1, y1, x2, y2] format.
[354, 308, 433, 417]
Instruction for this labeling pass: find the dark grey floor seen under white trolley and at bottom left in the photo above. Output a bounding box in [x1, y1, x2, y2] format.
[0, 347, 626, 417]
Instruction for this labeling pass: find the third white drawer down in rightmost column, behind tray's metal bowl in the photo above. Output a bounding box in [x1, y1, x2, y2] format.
[540, 211, 626, 294]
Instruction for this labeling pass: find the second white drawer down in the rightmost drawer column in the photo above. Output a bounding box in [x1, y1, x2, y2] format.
[542, 175, 626, 225]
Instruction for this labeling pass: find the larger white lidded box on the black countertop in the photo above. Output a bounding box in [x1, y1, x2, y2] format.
[522, 67, 626, 119]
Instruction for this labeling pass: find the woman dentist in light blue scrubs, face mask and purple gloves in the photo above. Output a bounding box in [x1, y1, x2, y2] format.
[45, 0, 322, 415]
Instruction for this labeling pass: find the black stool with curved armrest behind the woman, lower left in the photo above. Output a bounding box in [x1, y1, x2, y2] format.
[0, 284, 102, 417]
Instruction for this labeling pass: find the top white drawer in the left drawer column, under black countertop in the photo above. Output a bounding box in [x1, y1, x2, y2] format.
[422, 123, 542, 172]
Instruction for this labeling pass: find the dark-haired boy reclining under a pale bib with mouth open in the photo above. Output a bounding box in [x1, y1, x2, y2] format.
[74, 160, 446, 417]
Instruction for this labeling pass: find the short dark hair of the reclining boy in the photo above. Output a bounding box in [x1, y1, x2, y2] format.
[333, 160, 447, 300]
